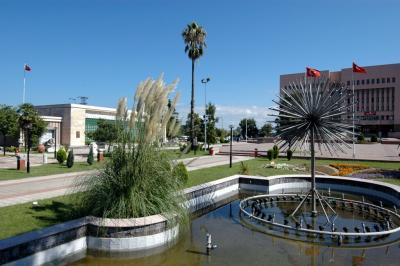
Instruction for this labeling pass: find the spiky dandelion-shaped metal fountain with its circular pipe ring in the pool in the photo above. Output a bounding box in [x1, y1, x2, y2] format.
[239, 79, 400, 246]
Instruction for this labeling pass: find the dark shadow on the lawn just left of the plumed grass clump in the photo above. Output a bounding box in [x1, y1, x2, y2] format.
[30, 201, 82, 224]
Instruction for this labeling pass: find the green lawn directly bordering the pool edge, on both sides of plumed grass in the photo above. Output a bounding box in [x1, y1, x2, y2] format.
[0, 158, 400, 239]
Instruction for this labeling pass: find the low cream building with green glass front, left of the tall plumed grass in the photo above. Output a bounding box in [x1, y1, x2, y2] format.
[35, 104, 117, 147]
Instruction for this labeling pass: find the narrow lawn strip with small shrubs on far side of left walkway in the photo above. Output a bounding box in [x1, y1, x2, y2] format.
[0, 162, 103, 181]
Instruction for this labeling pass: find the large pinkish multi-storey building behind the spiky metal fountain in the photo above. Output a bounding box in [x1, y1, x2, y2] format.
[280, 64, 400, 138]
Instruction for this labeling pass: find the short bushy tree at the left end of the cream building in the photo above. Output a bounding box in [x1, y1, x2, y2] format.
[17, 103, 47, 150]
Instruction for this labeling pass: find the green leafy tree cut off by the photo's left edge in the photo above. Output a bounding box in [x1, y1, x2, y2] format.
[0, 105, 19, 155]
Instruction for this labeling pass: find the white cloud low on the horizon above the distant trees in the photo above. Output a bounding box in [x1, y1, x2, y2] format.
[177, 105, 274, 128]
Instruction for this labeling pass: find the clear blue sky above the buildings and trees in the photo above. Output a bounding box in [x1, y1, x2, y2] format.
[0, 0, 400, 127]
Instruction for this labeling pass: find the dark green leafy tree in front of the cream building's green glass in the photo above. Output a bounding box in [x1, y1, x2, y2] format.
[87, 119, 118, 149]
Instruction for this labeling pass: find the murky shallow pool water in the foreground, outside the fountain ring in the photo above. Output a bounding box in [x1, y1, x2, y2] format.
[71, 193, 400, 266]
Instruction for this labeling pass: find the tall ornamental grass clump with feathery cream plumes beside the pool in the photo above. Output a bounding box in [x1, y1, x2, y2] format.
[77, 76, 187, 222]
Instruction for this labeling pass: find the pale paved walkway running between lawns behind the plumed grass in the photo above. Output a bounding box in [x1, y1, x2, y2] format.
[0, 155, 251, 207]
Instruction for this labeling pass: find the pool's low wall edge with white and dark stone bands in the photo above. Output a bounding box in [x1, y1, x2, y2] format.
[0, 175, 400, 265]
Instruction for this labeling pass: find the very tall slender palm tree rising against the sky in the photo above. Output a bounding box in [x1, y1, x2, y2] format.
[182, 22, 207, 150]
